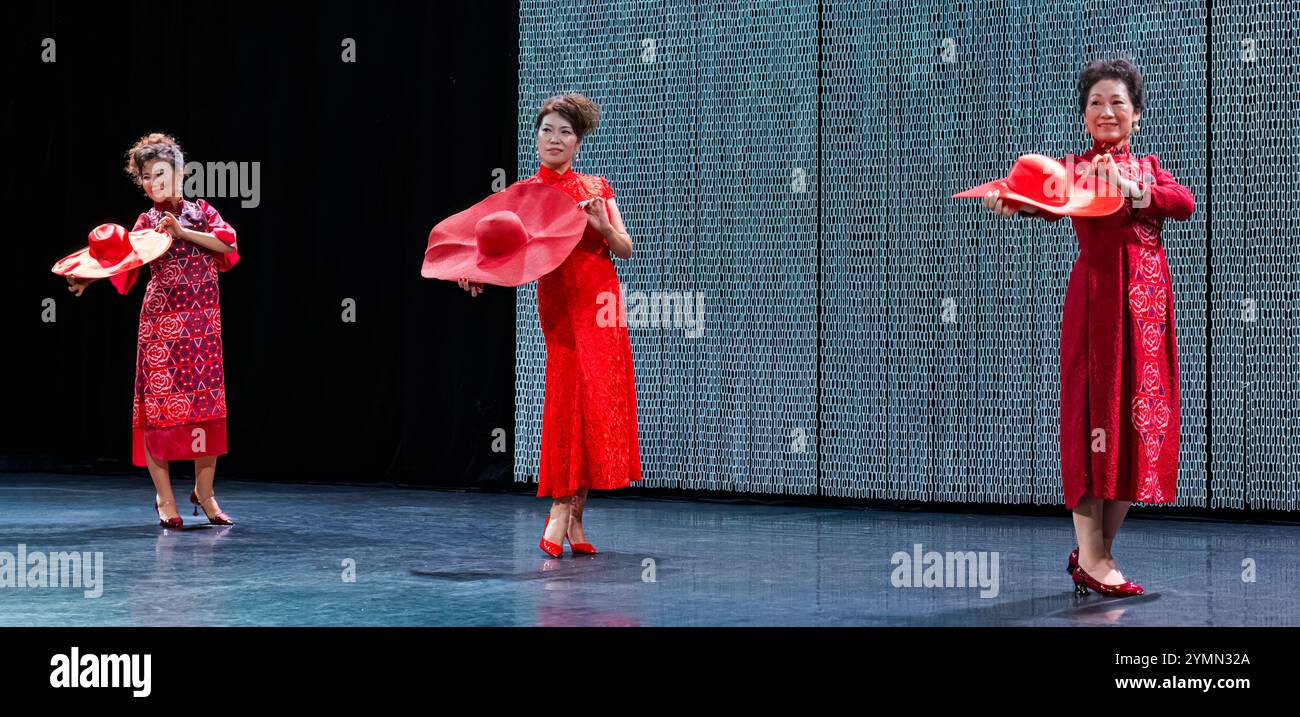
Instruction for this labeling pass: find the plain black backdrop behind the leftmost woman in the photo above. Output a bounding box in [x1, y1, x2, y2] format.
[0, 1, 519, 484]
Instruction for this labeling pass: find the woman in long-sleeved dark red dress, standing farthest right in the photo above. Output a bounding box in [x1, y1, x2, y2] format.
[984, 60, 1196, 595]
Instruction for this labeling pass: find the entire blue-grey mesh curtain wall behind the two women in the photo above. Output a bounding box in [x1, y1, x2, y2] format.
[515, 0, 1300, 510]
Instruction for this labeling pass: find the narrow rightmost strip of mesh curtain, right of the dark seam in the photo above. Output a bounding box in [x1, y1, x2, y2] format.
[1209, 0, 1300, 510]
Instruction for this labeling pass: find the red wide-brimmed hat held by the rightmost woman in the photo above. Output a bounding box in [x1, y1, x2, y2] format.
[953, 155, 1125, 217]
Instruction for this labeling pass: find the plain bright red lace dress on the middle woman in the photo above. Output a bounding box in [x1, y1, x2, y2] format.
[519, 165, 641, 497]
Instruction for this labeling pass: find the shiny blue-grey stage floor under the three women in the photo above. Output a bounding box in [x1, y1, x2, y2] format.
[0, 474, 1300, 626]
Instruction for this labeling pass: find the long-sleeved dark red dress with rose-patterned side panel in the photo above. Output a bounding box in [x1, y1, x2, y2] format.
[1044, 143, 1196, 508]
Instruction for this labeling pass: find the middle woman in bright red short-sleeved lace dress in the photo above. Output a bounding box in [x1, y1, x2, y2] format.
[460, 92, 641, 557]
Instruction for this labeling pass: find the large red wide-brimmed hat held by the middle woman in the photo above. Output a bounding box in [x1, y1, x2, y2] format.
[420, 184, 586, 286]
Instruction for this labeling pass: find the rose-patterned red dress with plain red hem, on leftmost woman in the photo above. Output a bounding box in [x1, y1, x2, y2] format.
[112, 199, 239, 466]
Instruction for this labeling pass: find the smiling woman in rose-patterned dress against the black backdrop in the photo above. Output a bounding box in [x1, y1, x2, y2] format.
[69, 134, 239, 527]
